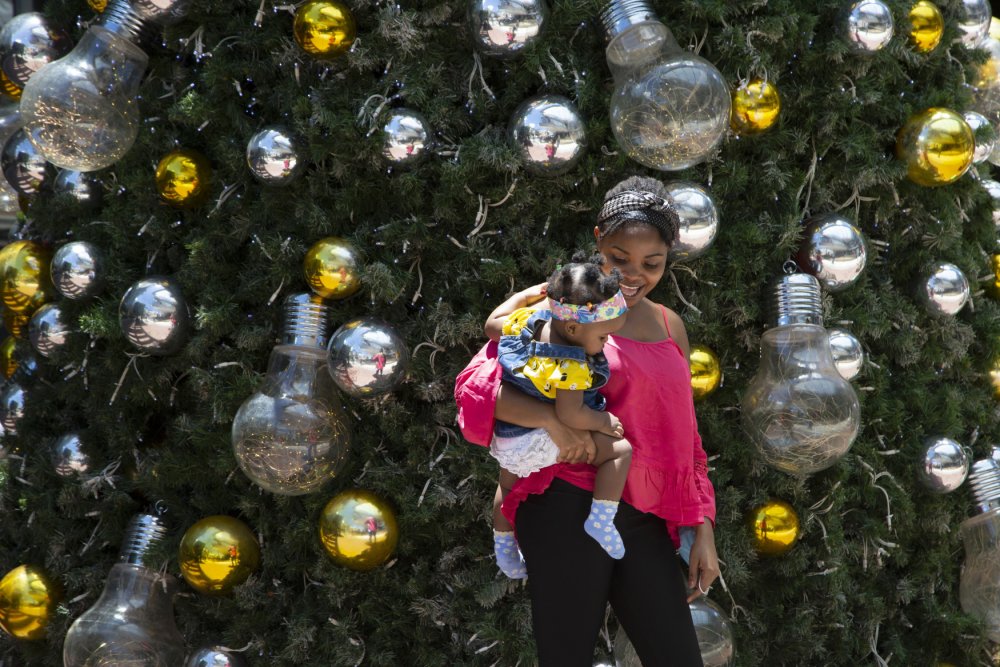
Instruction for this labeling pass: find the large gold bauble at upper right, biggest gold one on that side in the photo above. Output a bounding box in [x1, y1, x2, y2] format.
[896, 107, 976, 187]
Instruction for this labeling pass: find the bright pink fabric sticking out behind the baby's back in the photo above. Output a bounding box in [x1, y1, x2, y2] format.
[455, 341, 503, 447]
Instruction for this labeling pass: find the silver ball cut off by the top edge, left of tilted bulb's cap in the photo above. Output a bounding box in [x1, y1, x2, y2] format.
[469, 0, 549, 58]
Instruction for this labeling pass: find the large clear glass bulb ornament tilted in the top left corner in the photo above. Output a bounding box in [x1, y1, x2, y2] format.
[21, 0, 188, 171]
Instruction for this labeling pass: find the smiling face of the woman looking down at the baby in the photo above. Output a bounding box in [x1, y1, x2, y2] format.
[594, 224, 670, 308]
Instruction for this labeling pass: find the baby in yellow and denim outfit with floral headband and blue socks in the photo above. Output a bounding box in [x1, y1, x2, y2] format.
[486, 253, 632, 579]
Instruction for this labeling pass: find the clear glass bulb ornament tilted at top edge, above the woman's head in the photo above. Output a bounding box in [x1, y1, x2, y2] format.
[601, 0, 731, 171]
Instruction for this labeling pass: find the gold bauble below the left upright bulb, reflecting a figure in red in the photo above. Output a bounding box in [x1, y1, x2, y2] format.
[319, 489, 399, 570]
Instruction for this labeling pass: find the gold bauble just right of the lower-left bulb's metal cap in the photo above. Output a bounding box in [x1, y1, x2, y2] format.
[179, 515, 260, 595]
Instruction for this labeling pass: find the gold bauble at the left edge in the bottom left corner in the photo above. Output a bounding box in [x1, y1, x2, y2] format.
[0, 565, 60, 639]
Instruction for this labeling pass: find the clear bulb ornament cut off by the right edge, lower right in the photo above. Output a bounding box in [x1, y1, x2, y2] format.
[958, 458, 1000, 643]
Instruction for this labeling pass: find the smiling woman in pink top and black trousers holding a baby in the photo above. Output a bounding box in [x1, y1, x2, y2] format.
[456, 177, 719, 667]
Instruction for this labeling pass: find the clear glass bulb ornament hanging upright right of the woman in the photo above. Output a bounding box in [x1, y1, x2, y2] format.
[742, 273, 861, 475]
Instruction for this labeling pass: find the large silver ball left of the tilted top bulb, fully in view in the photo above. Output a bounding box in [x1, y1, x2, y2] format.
[507, 95, 587, 176]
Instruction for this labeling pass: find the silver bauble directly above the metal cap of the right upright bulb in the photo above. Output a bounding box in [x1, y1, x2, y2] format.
[797, 213, 868, 292]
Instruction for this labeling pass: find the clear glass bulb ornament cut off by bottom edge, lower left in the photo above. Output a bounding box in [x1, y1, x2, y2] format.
[63, 515, 184, 667]
